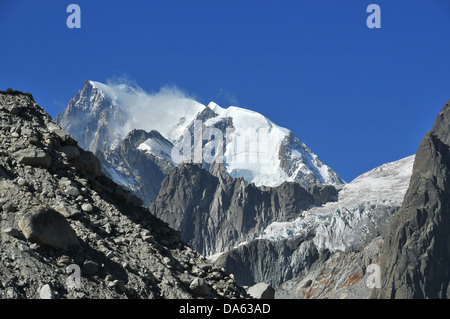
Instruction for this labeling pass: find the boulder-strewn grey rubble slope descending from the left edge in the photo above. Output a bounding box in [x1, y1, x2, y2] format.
[0, 90, 245, 298]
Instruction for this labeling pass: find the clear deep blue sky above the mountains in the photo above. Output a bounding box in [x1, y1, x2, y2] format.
[0, 0, 450, 181]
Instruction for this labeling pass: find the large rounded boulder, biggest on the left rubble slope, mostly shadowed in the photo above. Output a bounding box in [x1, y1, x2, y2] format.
[19, 209, 80, 249]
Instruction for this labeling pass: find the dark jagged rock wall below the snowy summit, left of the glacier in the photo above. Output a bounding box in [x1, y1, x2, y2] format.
[150, 164, 337, 255]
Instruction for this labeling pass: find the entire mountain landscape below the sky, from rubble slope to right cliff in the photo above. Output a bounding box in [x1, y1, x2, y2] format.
[0, 81, 450, 299]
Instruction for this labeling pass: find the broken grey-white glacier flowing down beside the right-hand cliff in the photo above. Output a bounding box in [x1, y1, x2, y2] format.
[260, 155, 414, 252]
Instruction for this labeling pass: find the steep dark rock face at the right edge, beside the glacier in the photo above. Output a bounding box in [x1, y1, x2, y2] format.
[372, 102, 450, 299]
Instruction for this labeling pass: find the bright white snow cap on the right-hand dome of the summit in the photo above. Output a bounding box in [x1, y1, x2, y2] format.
[199, 102, 343, 186]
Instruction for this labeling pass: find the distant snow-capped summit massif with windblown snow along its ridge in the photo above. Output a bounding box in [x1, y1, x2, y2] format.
[55, 81, 343, 204]
